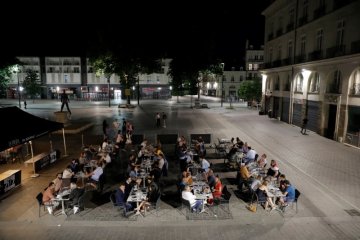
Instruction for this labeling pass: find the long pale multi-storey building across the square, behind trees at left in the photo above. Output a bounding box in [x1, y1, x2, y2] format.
[8, 57, 171, 101]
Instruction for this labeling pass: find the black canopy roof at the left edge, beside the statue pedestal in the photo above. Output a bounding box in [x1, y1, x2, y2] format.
[0, 107, 64, 151]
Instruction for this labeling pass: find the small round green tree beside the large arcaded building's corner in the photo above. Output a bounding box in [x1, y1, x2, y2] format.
[238, 79, 261, 102]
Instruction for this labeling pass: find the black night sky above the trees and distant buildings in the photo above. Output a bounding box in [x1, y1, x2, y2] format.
[0, 0, 270, 68]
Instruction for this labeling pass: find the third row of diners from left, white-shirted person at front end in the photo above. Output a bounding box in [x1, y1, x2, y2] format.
[176, 136, 223, 213]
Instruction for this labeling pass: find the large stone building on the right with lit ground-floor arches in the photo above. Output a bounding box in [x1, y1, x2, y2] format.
[261, 0, 360, 147]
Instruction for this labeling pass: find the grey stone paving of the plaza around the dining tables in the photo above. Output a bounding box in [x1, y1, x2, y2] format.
[0, 96, 360, 240]
